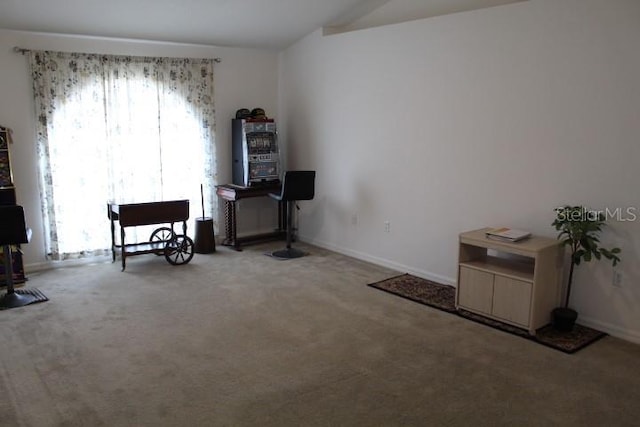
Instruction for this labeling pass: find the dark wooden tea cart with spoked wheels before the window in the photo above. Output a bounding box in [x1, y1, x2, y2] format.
[107, 200, 193, 271]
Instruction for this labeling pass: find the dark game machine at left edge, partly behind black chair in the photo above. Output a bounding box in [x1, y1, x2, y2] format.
[0, 126, 25, 286]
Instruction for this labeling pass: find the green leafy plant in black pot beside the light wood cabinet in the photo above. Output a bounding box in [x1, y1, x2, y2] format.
[551, 206, 620, 332]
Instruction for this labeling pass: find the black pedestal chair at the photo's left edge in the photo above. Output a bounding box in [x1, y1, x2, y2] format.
[0, 205, 37, 308]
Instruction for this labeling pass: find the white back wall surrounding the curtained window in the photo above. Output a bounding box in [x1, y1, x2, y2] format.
[0, 30, 278, 273]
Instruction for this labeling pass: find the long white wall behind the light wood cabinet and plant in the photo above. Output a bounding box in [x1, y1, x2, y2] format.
[279, 0, 640, 342]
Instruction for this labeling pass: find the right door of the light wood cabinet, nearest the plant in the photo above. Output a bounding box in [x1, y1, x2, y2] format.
[493, 276, 531, 327]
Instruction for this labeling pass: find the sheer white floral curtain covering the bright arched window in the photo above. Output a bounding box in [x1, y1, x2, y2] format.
[30, 52, 217, 259]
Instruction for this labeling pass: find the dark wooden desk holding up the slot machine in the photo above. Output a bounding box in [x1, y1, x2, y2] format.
[216, 184, 287, 251]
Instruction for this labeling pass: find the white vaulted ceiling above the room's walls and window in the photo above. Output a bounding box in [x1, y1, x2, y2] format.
[0, 0, 523, 50]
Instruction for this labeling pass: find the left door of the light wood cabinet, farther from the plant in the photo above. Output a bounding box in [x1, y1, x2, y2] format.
[458, 266, 493, 314]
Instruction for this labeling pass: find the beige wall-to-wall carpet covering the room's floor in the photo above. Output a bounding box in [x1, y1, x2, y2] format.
[0, 242, 640, 427]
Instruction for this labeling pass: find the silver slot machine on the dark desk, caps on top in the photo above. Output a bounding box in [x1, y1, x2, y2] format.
[231, 118, 280, 187]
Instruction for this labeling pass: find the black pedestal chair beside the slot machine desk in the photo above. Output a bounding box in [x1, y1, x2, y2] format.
[269, 171, 316, 259]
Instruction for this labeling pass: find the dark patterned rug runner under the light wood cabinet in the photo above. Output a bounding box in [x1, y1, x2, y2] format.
[368, 274, 607, 353]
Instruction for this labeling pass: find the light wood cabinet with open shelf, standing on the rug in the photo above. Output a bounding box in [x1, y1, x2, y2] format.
[456, 228, 563, 335]
